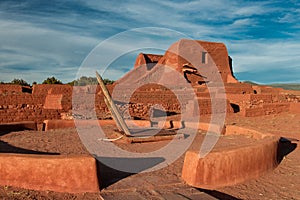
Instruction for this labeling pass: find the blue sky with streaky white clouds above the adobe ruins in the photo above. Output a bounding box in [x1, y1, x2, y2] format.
[0, 0, 300, 83]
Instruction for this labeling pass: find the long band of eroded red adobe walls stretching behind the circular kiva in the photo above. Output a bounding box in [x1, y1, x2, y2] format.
[0, 81, 300, 124]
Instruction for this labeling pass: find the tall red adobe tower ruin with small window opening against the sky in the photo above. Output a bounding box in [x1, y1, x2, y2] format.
[134, 39, 238, 83]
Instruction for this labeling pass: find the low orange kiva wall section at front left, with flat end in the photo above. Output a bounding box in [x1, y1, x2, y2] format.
[0, 153, 99, 193]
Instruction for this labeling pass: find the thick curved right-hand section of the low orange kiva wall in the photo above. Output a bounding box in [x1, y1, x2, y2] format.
[182, 126, 279, 189]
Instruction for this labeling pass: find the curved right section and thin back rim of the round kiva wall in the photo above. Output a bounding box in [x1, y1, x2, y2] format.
[46, 120, 279, 189]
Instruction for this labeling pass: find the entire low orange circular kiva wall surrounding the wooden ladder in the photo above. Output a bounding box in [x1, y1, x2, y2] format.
[0, 120, 279, 193]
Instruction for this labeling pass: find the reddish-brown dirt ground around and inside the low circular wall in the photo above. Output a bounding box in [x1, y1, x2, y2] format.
[0, 113, 300, 199]
